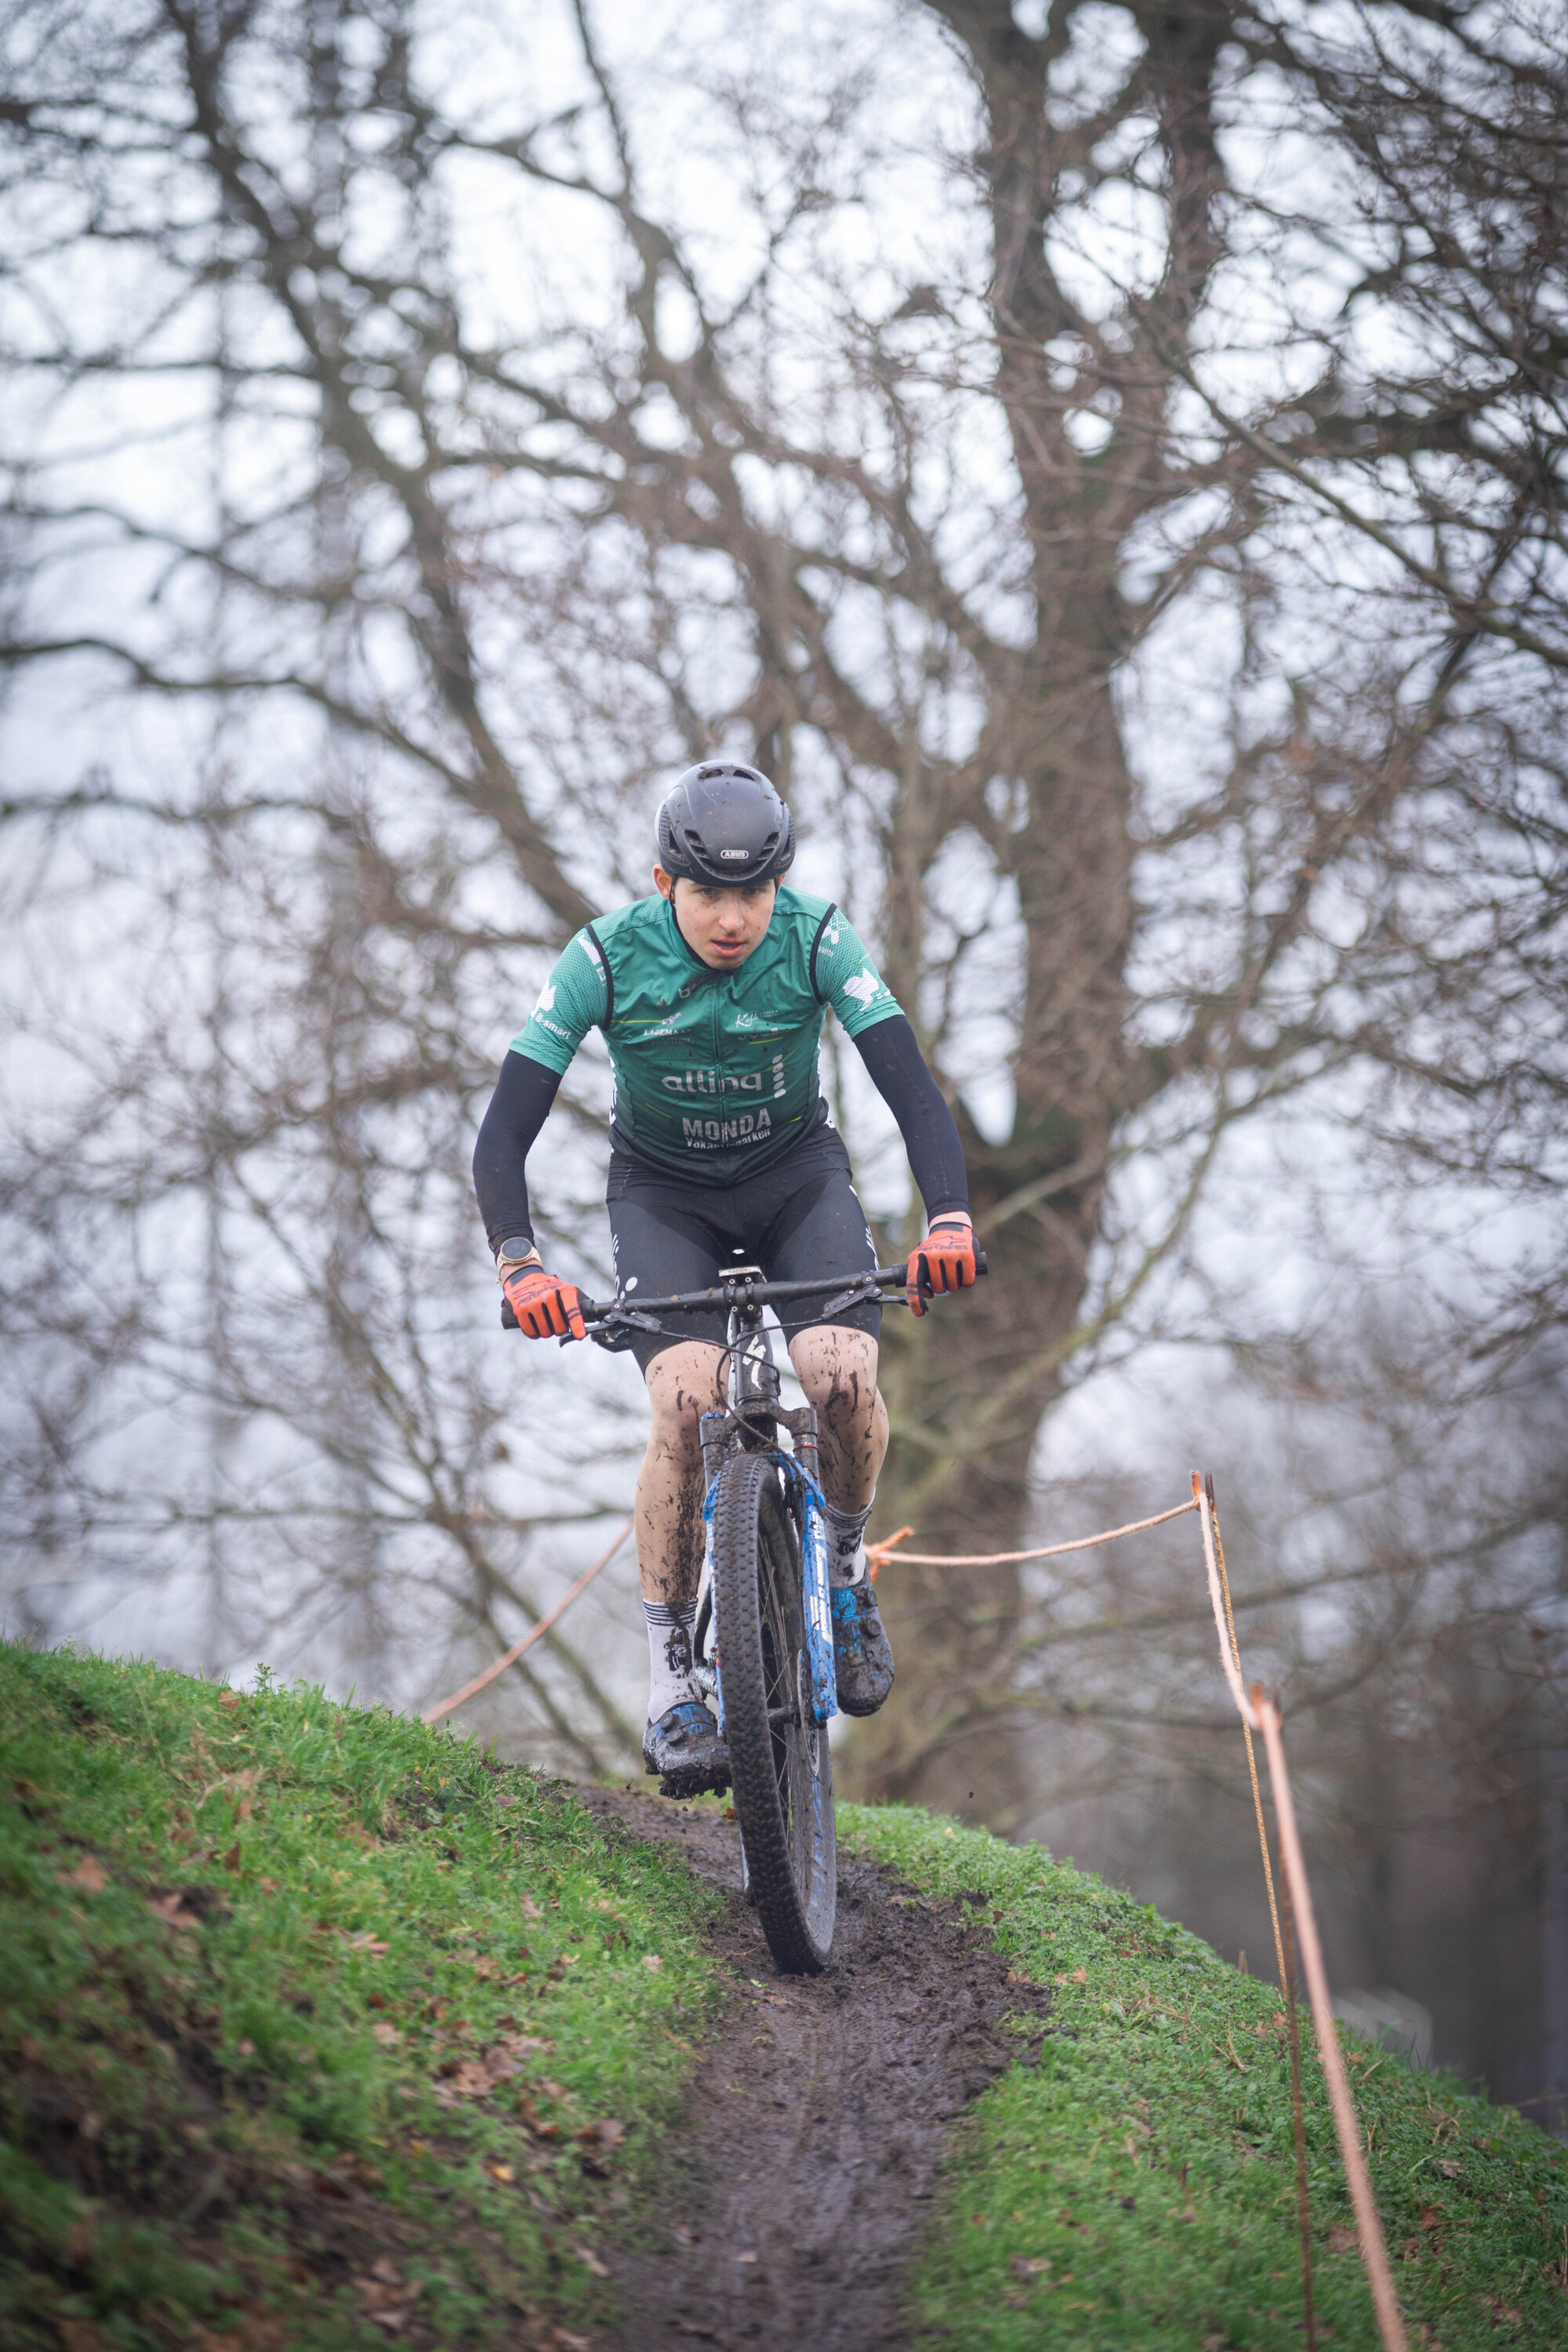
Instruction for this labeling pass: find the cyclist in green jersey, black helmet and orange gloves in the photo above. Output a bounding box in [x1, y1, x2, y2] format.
[475, 760, 975, 1797]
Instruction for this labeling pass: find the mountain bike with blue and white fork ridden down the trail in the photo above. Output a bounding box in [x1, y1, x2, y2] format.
[503, 1251, 985, 1976]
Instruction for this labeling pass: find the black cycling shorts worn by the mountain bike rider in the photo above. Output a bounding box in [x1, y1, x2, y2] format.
[607, 1127, 881, 1371]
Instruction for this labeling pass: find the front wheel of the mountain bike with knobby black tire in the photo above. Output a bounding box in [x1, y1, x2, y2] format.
[713, 1454, 839, 1976]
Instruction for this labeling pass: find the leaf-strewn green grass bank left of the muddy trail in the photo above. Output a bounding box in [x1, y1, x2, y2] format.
[0, 1646, 724, 2352]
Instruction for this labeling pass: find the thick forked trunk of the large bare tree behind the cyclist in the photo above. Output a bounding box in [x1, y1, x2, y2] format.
[846, 0, 1225, 1830]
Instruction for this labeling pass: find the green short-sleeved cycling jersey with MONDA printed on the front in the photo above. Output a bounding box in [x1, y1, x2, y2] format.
[513, 889, 902, 1185]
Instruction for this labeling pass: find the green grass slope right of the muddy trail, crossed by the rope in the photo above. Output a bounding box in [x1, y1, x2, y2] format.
[839, 1806, 1568, 2352]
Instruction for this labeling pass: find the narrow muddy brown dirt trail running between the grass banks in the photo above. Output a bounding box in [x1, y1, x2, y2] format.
[576, 1788, 1046, 2352]
